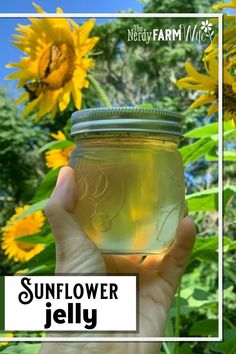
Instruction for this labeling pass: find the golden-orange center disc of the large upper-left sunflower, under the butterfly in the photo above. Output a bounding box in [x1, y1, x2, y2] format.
[38, 42, 75, 90]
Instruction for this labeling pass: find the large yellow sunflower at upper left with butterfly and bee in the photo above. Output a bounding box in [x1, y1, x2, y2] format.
[7, 4, 99, 120]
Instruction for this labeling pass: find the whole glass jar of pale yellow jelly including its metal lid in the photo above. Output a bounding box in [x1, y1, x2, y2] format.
[70, 107, 185, 254]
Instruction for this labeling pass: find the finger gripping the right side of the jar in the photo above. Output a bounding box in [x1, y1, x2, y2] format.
[158, 217, 196, 292]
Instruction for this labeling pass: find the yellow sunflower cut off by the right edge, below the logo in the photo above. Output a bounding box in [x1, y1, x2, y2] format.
[176, 57, 236, 124]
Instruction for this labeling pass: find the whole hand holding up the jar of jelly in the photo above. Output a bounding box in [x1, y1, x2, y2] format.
[40, 167, 196, 354]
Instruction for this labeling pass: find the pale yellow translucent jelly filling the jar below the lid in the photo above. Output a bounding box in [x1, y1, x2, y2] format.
[71, 134, 184, 254]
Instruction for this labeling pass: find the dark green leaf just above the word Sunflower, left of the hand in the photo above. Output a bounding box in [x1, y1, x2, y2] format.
[16, 243, 56, 271]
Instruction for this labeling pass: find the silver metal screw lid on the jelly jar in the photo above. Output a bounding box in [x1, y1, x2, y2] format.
[71, 107, 182, 136]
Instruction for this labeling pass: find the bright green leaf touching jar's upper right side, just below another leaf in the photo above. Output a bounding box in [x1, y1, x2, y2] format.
[179, 138, 216, 165]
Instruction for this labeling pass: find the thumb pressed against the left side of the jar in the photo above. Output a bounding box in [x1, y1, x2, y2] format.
[44, 166, 105, 273]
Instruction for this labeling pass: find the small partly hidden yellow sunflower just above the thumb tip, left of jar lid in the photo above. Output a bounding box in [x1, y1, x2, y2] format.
[45, 131, 75, 169]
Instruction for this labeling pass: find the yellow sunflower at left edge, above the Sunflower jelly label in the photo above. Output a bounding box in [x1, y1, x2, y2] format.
[1, 205, 45, 262]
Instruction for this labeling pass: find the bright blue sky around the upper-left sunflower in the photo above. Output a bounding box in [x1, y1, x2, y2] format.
[0, 0, 143, 87]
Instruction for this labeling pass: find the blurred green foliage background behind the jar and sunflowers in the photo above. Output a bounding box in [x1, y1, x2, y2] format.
[0, 0, 236, 354]
